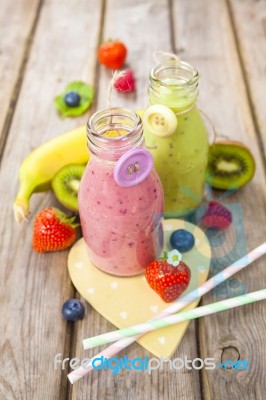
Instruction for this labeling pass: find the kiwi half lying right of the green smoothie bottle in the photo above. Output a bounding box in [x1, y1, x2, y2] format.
[206, 141, 256, 190]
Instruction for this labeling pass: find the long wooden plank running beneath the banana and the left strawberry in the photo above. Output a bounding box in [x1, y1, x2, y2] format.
[0, 0, 101, 400]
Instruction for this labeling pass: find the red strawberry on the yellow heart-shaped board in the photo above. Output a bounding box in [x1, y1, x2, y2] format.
[145, 260, 190, 303]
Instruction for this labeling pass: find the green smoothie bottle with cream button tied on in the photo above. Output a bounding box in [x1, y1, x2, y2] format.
[143, 60, 209, 217]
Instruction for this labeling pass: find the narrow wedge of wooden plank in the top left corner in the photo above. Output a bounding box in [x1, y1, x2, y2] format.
[0, 0, 40, 154]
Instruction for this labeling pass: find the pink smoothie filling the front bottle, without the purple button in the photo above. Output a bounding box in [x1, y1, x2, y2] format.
[79, 111, 163, 276]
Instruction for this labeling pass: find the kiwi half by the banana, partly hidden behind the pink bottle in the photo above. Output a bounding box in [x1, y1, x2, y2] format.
[52, 164, 86, 211]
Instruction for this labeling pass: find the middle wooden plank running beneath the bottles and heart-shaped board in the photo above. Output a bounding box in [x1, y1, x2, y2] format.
[72, 0, 200, 400]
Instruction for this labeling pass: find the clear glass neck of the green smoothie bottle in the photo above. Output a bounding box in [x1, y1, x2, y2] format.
[149, 60, 199, 113]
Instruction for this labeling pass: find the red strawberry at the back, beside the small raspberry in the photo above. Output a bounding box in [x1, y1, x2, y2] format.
[98, 41, 127, 69]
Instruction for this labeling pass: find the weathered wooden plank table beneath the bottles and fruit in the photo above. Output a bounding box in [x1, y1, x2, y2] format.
[0, 0, 266, 400]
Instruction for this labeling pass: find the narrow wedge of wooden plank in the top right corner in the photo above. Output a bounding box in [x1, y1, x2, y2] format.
[228, 0, 266, 165]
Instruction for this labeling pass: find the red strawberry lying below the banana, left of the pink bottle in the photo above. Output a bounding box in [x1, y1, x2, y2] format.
[32, 208, 79, 253]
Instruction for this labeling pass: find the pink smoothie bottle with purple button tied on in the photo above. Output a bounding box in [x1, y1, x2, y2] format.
[79, 108, 163, 276]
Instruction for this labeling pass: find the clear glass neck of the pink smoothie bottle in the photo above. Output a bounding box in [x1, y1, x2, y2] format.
[87, 108, 144, 161]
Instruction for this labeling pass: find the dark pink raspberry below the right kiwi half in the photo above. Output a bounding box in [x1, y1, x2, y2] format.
[201, 201, 232, 229]
